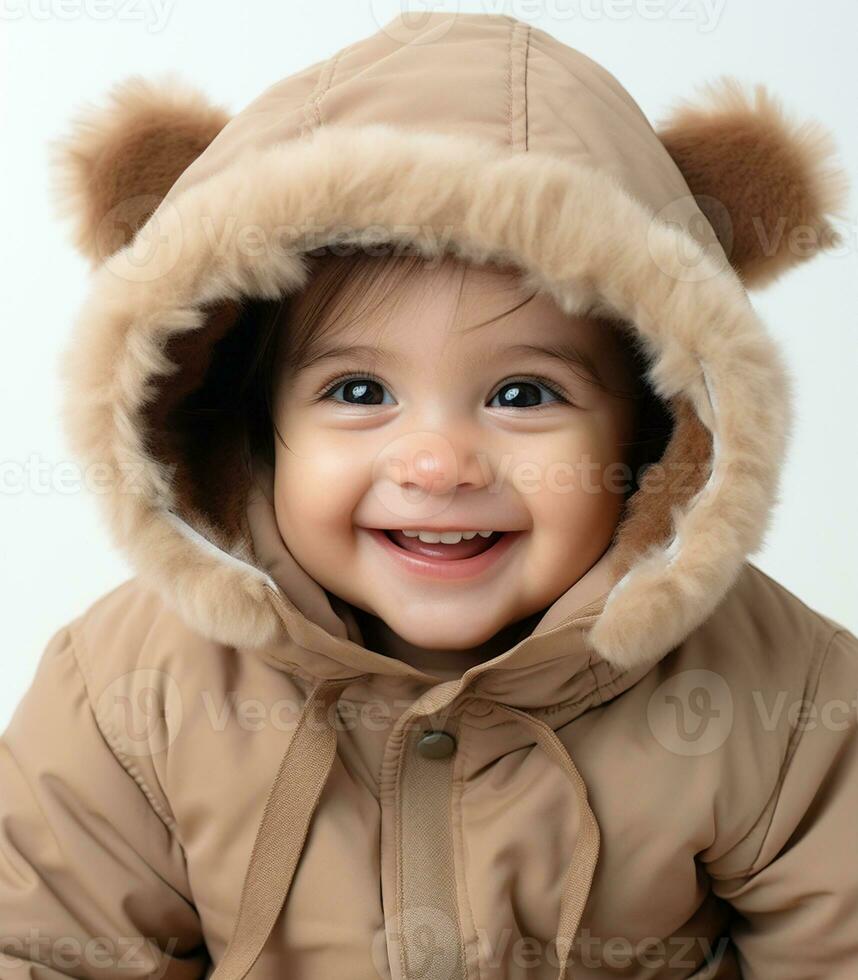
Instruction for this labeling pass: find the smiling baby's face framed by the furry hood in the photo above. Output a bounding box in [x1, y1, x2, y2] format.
[274, 267, 635, 650]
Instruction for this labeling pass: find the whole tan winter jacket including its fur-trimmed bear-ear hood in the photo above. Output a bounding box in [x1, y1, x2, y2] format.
[0, 12, 858, 980]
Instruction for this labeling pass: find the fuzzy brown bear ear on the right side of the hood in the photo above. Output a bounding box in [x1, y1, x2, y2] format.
[654, 75, 849, 289]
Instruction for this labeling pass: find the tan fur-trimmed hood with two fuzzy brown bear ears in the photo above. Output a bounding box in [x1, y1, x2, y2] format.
[55, 12, 844, 669]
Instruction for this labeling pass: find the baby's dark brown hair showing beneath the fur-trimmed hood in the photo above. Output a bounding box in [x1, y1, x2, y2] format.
[239, 245, 672, 497]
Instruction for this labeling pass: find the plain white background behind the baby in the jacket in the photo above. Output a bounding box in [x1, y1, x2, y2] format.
[0, 0, 858, 728]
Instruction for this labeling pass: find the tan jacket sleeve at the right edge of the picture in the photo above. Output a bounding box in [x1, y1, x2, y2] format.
[713, 629, 858, 980]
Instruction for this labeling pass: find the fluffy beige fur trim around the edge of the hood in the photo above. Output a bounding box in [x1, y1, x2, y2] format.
[58, 123, 790, 667]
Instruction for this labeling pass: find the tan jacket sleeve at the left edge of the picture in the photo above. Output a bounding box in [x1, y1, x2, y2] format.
[0, 627, 208, 980]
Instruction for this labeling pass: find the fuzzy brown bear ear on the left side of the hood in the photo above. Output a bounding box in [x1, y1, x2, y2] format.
[48, 73, 230, 265]
